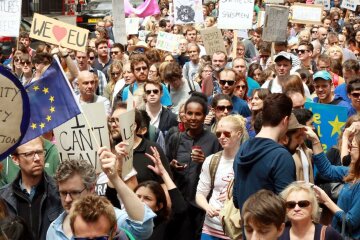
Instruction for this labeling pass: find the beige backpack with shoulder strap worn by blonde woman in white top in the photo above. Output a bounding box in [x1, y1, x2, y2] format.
[207, 151, 242, 239]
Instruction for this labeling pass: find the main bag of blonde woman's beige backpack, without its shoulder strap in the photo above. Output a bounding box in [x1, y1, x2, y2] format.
[220, 180, 242, 239]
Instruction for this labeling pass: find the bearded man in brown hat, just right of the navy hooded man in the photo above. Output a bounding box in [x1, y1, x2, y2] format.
[279, 113, 314, 183]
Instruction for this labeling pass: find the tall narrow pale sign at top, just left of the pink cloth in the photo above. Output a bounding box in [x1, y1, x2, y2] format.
[112, 0, 127, 45]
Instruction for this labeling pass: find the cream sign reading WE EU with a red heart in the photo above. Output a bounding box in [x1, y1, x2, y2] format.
[30, 13, 89, 52]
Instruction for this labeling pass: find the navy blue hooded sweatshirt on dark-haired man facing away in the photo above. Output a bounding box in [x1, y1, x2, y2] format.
[233, 137, 296, 209]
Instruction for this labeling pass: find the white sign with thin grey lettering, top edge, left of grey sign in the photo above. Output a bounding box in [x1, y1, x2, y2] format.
[217, 0, 254, 29]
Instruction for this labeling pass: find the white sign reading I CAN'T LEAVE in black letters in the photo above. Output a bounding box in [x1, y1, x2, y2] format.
[54, 103, 110, 172]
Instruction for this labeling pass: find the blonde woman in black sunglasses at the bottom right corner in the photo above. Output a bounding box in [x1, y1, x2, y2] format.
[279, 182, 342, 240]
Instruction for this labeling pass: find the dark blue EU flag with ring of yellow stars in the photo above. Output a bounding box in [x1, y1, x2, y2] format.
[21, 59, 80, 144]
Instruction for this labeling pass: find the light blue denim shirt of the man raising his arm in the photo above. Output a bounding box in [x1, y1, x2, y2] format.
[46, 205, 156, 240]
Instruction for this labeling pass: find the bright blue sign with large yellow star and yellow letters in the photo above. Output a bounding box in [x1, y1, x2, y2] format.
[305, 102, 347, 151]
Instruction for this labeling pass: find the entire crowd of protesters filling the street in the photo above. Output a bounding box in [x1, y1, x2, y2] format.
[0, 0, 360, 240]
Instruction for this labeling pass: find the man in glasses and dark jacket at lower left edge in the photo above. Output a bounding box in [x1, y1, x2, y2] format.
[0, 137, 62, 240]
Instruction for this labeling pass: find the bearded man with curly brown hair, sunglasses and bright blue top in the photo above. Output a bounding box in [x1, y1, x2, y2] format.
[122, 54, 172, 106]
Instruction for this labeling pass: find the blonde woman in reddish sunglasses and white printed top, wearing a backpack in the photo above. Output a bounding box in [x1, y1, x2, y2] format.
[196, 115, 246, 240]
